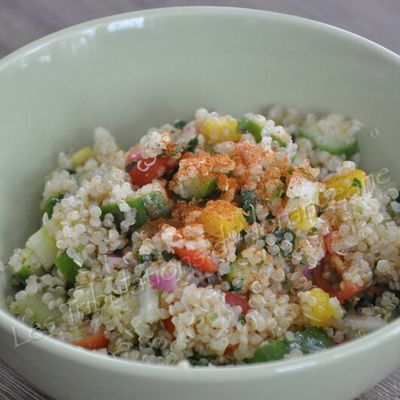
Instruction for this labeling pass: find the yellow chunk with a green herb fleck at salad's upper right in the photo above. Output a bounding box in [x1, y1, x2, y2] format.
[325, 169, 366, 200]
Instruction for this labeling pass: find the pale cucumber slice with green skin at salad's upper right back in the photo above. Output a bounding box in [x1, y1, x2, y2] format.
[299, 126, 358, 158]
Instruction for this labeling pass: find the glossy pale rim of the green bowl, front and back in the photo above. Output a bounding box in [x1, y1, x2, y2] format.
[0, 6, 400, 383]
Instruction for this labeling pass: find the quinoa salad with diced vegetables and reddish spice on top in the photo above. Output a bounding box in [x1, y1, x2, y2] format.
[6, 106, 400, 366]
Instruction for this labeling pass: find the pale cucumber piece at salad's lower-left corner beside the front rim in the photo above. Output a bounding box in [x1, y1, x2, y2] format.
[10, 293, 61, 329]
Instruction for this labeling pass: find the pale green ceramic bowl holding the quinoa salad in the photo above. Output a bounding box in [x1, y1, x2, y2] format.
[0, 7, 400, 400]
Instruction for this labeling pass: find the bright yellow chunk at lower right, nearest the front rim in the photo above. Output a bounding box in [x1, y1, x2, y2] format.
[300, 288, 337, 327]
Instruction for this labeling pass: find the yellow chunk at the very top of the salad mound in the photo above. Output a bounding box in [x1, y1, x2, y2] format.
[200, 116, 242, 144]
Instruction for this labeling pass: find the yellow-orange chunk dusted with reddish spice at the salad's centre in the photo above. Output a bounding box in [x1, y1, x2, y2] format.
[200, 200, 248, 239]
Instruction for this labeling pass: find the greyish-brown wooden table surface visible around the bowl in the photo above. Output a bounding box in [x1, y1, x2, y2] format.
[0, 0, 400, 400]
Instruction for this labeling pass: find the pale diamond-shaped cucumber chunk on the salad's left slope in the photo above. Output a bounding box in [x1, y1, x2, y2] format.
[26, 226, 57, 270]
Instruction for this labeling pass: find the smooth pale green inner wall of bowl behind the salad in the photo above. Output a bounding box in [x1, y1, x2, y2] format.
[0, 8, 400, 307]
